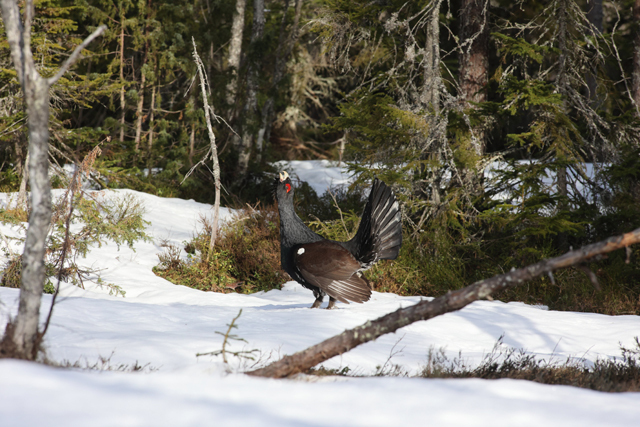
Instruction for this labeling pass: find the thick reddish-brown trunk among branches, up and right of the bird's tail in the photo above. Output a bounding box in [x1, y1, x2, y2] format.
[459, 0, 489, 156]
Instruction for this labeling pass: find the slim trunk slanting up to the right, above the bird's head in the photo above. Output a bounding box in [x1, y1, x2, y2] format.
[256, 0, 302, 166]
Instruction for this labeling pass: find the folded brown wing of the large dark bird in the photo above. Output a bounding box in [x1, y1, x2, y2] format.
[294, 240, 371, 304]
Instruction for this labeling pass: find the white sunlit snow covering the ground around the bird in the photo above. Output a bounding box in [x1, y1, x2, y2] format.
[0, 166, 640, 427]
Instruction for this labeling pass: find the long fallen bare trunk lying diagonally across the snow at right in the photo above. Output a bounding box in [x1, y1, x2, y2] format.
[247, 228, 640, 378]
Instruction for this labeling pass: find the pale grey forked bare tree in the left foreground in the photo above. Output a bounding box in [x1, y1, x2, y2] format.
[0, 0, 106, 360]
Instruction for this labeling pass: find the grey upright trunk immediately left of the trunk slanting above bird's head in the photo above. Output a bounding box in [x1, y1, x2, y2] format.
[236, 0, 265, 177]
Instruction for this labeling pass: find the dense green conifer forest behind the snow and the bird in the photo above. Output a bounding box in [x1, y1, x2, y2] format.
[0, 0, 640, 324]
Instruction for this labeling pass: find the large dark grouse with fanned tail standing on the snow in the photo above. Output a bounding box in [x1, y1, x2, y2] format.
[276, 172, 402, 308]
